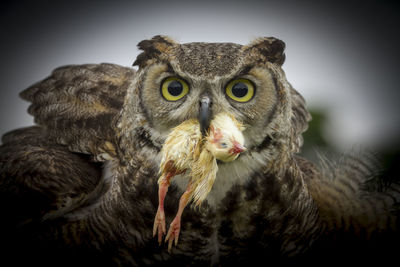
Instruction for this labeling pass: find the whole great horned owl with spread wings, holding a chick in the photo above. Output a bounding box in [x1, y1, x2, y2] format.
[0, 36, 400, 266]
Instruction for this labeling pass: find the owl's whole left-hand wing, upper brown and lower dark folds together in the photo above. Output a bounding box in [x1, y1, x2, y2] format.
[0, 64, 135, 223]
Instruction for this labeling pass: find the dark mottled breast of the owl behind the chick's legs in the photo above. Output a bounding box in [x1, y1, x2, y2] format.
[46, 153, 320, 265]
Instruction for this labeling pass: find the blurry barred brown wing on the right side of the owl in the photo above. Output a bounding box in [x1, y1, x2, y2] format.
[309, 148, 400, 240]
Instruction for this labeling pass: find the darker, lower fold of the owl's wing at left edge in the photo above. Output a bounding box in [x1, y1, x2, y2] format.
[0, 126, 108, 226]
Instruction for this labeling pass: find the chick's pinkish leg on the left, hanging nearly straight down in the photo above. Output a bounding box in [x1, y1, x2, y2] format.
[153, 173, 174, 245]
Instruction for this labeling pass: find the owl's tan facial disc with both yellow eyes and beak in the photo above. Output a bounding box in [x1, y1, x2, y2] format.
[139, 58, 278, 154]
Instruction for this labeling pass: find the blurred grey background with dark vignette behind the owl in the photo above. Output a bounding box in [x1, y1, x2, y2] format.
[0, 0, 400, 175]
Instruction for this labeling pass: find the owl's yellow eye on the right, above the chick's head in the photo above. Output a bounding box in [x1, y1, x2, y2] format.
[226, 79, 254, 103]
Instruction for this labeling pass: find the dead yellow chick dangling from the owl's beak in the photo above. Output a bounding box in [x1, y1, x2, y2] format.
[153, 113, 246, 251]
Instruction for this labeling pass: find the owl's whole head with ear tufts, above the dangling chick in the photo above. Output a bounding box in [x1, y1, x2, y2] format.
[118, 36, 309, 173]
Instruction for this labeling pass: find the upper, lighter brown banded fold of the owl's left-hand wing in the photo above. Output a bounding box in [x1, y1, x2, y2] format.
[20, 63, 135, 161]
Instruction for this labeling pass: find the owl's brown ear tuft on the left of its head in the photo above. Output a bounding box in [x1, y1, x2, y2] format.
[133, 35, 177, 68]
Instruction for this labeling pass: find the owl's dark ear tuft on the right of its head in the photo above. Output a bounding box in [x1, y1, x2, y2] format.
[243, 37, 286, 65]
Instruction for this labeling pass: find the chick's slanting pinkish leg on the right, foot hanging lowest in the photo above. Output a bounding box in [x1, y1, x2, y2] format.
[165, 181, 192, 252]
